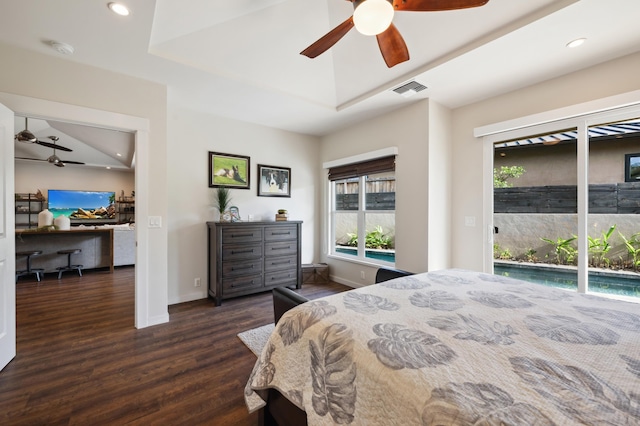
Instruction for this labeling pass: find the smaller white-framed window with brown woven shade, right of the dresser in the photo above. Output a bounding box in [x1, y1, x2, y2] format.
[329, 156, 396, 266]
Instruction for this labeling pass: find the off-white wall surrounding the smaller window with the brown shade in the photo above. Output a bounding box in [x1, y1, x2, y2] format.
[317, 100, 440, 287]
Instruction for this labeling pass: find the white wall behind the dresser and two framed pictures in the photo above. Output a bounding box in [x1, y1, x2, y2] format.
[167, 102, 320, 304]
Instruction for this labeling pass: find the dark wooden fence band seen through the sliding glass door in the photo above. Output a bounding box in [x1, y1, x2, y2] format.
[493, 182, 640, 214]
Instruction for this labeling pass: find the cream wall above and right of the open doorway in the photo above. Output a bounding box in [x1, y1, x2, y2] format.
[0, 44, 170, 326]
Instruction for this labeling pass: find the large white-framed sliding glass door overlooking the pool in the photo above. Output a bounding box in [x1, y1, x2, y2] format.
[485, 106, 640, 299]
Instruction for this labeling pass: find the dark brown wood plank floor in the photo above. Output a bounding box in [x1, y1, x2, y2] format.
[0, 267, 348, 425]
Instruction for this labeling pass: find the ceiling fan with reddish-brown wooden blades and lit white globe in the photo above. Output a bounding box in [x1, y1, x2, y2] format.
[300, 0, 489, 68]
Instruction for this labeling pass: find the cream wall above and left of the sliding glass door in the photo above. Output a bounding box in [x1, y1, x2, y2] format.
[451, 54, 640, 271]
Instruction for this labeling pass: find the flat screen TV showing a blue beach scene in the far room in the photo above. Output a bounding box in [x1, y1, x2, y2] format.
[49, 189, 116, 224]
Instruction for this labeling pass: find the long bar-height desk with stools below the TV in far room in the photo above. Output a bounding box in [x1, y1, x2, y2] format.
[16, 228, 113, 273]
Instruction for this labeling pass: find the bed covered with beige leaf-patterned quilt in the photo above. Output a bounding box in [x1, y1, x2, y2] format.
[245, 270, 640, 425]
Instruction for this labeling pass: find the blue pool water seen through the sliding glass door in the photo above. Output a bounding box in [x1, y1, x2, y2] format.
[493, 263, 640, 297]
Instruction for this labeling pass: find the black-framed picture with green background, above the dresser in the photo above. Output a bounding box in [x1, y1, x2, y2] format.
[209, 151, 250, 189]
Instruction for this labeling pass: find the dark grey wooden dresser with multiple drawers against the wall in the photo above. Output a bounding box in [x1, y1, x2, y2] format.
[207, 221, 302, 306]
